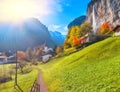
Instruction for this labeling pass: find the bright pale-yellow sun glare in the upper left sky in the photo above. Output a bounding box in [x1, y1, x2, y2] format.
[0, 0, 37, 21]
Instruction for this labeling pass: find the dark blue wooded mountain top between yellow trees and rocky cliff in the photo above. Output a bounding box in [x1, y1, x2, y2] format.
[68, 15, 87, 29]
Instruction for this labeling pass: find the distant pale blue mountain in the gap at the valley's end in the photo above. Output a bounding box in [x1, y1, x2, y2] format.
[49, 31, 65, 46]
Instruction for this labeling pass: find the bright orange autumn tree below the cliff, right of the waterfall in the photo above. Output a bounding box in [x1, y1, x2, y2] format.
[98, 22, 114, 34]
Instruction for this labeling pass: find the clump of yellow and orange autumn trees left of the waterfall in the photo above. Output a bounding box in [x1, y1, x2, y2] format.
[64, 22, 92, 49]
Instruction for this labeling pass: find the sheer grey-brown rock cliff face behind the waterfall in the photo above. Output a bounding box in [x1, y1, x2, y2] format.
[87, 0, 120, 27]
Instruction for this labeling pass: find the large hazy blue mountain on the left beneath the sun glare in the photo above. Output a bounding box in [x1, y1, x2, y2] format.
[0, 18, 55, 51]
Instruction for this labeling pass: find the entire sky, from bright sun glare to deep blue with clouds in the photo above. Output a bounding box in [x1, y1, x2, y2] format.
[0, 0, 90, 35]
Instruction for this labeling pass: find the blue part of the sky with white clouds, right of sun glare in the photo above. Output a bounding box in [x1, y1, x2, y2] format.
[45, 0, 90, 34]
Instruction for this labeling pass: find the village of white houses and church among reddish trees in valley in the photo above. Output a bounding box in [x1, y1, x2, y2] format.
[0, 44, 55, 64]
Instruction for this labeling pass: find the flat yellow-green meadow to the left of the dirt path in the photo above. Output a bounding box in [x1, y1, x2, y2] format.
[0, 64, 38, 92]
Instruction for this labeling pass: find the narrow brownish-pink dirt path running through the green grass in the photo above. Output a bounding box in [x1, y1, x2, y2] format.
[38, 70, 48, 92]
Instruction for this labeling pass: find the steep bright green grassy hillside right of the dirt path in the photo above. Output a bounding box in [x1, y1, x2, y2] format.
[39, 37, 120, 92]
